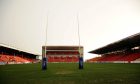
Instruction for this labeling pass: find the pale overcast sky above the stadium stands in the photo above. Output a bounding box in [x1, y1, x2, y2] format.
[0, 0, 140, 60]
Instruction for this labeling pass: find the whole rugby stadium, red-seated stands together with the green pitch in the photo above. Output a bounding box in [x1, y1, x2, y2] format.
[0, 34, 140, 84]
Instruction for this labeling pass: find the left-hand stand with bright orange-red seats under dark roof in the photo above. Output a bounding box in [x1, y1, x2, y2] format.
[0, 44, 39, 65]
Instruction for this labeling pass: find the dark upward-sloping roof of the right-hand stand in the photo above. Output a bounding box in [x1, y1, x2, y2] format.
[89, 33, 140, 54]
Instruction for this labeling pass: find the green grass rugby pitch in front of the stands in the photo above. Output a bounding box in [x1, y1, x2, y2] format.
[0, 63, 140, 84]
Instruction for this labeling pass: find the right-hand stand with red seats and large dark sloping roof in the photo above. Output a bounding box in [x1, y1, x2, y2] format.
[87, 33, 140, 63]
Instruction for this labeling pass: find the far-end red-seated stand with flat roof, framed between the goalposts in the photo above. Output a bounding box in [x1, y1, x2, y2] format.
[42, 46, 83, 63]
